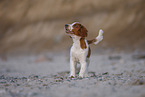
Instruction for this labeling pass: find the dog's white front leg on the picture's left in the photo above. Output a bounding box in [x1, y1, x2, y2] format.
[69, 57, 76, 78]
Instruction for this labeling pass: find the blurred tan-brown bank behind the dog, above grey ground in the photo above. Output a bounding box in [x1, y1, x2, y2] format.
[0, 0, 145, 54]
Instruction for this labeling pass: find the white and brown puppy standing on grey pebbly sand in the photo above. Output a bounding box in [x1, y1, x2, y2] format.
[65, 22, 103, 78]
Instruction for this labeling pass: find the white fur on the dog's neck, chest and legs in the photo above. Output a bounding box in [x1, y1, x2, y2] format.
[70, 35, 89, 78]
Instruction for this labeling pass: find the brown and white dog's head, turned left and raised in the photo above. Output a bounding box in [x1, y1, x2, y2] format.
[65, 22, 88, 38]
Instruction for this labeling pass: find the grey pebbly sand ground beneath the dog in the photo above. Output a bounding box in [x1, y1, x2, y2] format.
[0, 52, 145, 97]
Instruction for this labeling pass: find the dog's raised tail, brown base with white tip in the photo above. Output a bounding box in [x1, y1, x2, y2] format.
[87, 29, 104, 45]
